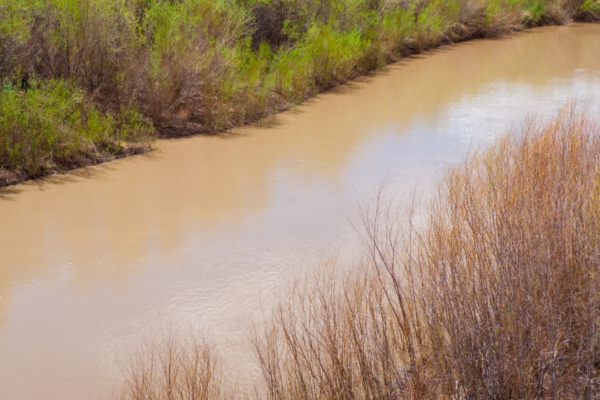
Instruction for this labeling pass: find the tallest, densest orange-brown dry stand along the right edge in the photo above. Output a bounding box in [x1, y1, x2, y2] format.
[410, 107, 600, 399]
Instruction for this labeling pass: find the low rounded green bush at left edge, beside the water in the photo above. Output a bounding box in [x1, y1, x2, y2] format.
[0, 80, 150, 180]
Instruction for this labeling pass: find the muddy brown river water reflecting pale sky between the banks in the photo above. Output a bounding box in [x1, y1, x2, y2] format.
[0, 25, 600, 399]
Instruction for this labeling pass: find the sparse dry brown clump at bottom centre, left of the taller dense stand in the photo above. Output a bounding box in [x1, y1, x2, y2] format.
[254, 265, 422, 400]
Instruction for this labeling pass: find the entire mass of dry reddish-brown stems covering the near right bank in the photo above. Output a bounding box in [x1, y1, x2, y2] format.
[119, 107, 600, 400]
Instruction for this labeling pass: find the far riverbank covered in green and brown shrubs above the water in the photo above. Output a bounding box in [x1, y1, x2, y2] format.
[0, 0, 600, 185]
